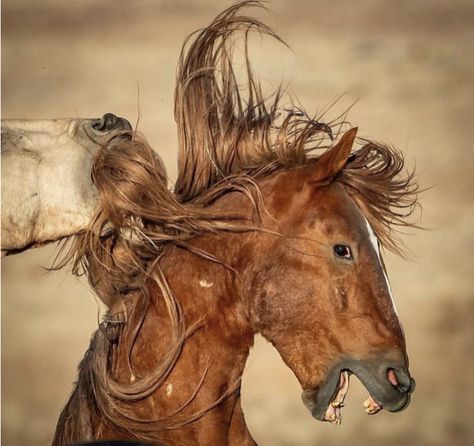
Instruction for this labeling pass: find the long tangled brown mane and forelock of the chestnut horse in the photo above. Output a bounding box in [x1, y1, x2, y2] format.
[55, 0, 418, 444]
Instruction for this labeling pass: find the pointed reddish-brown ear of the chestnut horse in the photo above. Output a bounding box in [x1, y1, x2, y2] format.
[315, 127, 357, 181]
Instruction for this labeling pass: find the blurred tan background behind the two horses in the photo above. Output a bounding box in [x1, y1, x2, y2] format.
[2, 0, 474, 446]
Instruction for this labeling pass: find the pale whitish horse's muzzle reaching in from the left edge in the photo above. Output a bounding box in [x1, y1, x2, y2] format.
[1, 113, 131, 256]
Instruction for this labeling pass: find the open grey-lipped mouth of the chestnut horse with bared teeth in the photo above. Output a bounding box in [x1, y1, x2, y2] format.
[302, 358, 415, 425]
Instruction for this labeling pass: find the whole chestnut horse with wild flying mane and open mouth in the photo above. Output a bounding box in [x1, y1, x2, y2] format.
[54, 1, 417, 445]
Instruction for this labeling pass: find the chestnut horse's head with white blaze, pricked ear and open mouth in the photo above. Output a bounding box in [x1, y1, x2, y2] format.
[245, 129, 414, 424]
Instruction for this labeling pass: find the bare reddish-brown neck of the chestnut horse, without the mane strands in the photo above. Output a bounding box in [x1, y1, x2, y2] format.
[101, 178, 292, 445]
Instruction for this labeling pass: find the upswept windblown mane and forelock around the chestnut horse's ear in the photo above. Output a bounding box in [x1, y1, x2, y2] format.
[175, 1, 417, 249]
